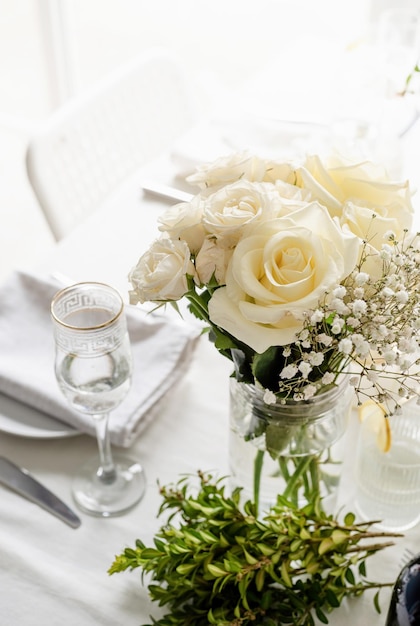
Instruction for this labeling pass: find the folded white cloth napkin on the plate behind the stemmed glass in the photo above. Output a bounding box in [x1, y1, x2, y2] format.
[0, 272, 200, 447]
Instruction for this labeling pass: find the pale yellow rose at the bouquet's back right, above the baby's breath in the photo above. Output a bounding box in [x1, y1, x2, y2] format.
[296, 156, 413, 247]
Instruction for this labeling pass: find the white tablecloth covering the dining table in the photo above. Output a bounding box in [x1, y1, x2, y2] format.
[0, 138, 420, 626]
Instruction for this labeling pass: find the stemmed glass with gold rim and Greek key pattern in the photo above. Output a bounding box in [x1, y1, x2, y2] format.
[51, 282, 145, 517]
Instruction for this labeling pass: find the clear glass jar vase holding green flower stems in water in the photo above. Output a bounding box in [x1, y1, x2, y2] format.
[229, 377, 354, 513]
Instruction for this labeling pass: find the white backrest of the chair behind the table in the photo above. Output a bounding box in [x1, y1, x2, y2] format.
[26, 50, 197, 240]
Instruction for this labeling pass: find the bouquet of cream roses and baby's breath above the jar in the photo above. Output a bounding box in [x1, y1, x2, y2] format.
[129, 153, 420, 414]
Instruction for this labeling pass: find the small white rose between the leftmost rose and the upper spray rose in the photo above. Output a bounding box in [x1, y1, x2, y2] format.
[158, 196, 205, 252]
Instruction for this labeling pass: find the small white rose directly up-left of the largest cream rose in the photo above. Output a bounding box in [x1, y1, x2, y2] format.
[203, 180, 281, 247]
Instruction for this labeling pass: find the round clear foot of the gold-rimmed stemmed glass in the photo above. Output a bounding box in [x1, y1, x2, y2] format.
[73, 455, 146, 517]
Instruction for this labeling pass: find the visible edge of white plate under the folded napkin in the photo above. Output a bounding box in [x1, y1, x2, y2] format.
[0, 394, 81, 439]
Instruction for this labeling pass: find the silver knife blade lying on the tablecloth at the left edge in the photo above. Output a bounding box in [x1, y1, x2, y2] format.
[0, 457, 81, 528]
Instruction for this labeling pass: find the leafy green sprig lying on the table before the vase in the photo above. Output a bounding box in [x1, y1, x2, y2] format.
[109, 472, 398, 626]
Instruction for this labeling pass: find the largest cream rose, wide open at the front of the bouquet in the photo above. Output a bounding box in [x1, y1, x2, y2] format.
[209, 202, 360, 353]
